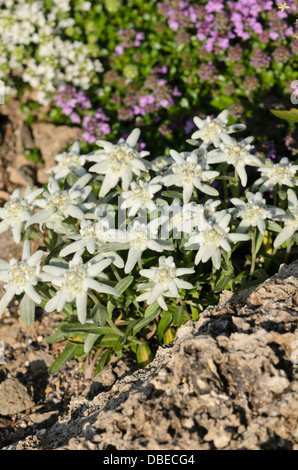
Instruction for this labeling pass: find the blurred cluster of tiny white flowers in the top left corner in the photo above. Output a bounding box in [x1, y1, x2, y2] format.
[0, 0, 103, 105]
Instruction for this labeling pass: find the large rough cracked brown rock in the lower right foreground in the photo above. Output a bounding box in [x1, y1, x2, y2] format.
[2, 261, 298, 450]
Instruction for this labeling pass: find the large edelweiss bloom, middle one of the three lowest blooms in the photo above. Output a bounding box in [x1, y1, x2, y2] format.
[43, 252, 120, 323]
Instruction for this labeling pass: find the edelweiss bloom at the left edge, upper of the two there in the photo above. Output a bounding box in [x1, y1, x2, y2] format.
[0, 188, 44, 243]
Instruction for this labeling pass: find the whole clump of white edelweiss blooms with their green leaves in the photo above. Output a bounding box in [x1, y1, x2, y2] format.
[0, 110, 298, 370]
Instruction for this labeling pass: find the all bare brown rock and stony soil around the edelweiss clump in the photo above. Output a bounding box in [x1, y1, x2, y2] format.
[0, 103, 298, 450]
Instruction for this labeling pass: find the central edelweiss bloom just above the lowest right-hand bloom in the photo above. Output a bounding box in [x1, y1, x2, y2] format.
[110, 217, 174, 274]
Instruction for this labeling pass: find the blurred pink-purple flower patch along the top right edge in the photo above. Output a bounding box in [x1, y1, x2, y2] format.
[158, 0, 295, 54]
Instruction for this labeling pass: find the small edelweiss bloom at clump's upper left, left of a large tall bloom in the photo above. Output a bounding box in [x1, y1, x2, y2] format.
[47, 142, 86, 181]
